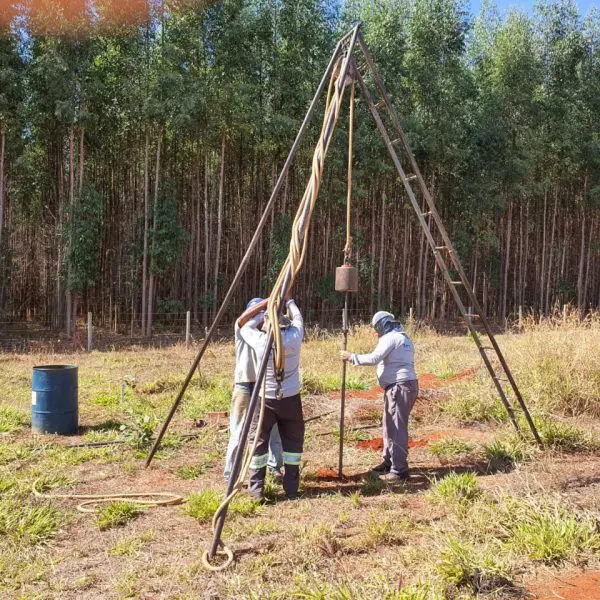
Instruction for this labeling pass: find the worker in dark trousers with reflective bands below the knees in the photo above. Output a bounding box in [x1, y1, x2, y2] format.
[241, 299, 304, 500]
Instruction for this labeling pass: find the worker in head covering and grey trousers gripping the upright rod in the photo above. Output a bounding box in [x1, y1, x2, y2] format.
[340, 310, 419, 483]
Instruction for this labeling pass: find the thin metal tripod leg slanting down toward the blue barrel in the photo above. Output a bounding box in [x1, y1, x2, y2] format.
[146, 42, 341, 467]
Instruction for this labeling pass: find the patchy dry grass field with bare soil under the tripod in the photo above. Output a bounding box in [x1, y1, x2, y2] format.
[0, 320, 600, 600]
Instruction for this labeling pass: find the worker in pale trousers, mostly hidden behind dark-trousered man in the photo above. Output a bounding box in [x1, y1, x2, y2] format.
[223, 298, 283, 480]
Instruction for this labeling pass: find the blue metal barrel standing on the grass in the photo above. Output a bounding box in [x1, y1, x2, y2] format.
[31, 365, 78, 435]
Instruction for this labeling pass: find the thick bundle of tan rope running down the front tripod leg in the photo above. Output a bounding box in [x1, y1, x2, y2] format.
[202, 49, 352, 571]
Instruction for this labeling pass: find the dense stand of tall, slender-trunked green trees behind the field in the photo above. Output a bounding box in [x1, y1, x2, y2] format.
[0, 0, 600, 335]
